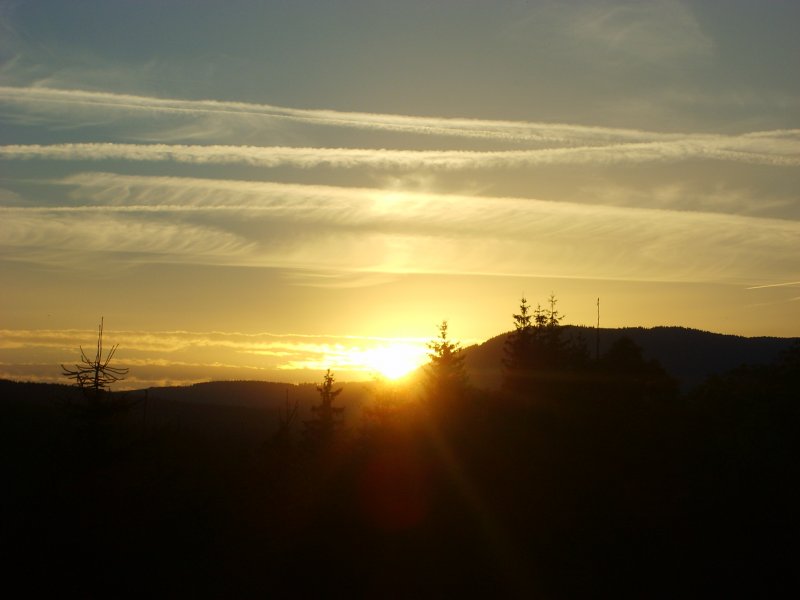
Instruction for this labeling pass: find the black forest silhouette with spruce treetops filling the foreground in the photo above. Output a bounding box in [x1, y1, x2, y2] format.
[0, 296, 800, 598]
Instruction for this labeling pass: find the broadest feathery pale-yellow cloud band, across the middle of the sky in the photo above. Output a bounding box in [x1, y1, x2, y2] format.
[0, 173, 800, 282]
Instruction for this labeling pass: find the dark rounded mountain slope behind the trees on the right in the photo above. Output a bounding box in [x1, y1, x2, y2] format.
[465, 326, 800, 390]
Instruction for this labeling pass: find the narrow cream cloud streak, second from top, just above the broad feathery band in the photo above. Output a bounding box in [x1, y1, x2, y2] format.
[0, 137, 800, 169]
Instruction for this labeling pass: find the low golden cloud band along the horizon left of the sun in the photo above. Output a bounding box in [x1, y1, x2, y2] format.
[0, 329, 438, 389]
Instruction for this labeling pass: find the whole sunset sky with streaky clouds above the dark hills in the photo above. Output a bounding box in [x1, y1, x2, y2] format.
[0, 0, 800, 387]
